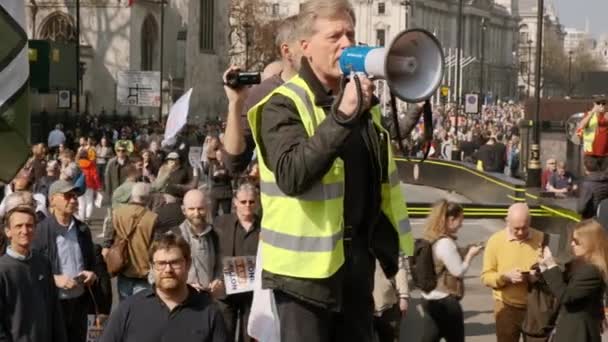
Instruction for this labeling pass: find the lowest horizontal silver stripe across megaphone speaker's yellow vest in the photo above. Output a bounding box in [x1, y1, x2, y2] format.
[261, 227, 343, 252]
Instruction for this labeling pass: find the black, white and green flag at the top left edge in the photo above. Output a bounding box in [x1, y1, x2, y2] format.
[0, 0, 30, 183]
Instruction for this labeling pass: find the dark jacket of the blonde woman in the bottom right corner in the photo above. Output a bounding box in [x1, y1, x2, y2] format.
[543, 263, 605, 342]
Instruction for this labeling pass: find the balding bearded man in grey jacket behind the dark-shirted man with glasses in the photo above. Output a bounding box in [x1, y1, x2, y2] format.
[176, 190, 224, 297]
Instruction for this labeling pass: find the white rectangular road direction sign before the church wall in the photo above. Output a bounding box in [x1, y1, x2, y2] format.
[116, 71, 160, 107]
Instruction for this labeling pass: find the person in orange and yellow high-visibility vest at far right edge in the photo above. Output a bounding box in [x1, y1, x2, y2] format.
[578, 97, 608, 171]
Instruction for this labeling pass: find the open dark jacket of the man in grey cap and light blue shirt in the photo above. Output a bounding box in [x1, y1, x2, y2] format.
[32, 215, 102, 278]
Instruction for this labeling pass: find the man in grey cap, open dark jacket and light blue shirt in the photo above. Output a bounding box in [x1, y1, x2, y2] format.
[33, 180, 101, 342]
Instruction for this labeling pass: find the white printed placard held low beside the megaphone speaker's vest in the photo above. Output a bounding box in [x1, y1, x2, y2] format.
[223, 256, 255, 294]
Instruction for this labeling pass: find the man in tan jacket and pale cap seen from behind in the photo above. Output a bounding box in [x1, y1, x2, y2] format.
[104, 183, 158, 301]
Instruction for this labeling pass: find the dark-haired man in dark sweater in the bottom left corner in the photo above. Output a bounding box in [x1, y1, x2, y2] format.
[0, 206, 67, 342]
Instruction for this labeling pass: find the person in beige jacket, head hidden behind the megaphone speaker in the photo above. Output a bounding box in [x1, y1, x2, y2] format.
[373, 258, 410, 342]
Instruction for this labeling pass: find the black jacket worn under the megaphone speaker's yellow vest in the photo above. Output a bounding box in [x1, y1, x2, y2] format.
[260, 59, 399, 309]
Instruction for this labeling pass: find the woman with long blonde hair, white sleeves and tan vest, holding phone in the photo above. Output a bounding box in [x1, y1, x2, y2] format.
[422, 200, 482, 342]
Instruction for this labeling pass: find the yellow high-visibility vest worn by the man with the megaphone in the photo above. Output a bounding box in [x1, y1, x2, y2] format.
[248, 76, 414, 279]
